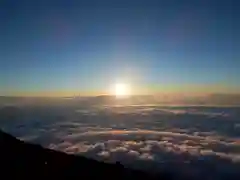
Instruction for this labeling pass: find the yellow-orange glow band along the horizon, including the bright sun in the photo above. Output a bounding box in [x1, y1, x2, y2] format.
[0, 83, 240, 97]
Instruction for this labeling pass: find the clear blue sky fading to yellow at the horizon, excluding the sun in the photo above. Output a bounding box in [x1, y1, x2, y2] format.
[0, 0, 240, 96]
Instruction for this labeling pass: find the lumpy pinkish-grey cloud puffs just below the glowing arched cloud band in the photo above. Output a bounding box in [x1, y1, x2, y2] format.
[50, 138, 239, 163]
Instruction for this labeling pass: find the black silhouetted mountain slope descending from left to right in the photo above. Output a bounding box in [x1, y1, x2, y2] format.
[0, 131, 172, 180]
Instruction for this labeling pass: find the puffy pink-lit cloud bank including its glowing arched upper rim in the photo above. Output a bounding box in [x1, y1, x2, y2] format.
[49, 131, 239, 162]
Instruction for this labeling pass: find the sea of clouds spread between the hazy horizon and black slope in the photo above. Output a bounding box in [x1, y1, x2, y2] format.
[1, 105, 240, 179]
